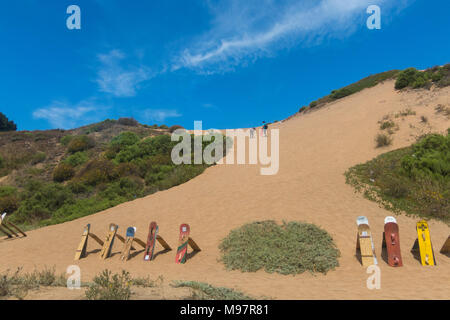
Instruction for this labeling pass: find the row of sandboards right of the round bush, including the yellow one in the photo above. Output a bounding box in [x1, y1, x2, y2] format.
[356, 216, 450, 267]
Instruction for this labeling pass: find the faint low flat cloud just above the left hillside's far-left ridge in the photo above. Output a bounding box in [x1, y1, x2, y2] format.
[33, 99, 107, 129]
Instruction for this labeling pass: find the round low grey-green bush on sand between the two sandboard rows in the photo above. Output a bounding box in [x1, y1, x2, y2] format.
[219, 221, 340, 275]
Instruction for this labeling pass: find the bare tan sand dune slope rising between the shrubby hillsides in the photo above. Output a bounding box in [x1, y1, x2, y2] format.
[0, 81, 450, 299]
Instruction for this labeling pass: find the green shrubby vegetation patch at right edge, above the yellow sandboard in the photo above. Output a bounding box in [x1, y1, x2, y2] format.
[346, 129, 450, 223]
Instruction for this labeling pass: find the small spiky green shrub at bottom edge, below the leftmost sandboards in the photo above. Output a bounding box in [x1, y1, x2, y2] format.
[85, 270, 131, 300]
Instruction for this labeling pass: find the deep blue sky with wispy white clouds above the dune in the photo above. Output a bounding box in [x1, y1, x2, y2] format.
[0, 0, 450, 130]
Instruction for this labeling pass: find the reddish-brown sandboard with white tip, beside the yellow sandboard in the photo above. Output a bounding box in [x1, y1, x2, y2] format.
[383, 216, 403, 267]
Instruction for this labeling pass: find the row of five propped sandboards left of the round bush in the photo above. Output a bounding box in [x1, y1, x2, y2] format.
[75, 221, 200, 263]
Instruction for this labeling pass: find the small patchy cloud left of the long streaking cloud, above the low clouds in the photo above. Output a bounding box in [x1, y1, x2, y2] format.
[96, 50, 152, 97]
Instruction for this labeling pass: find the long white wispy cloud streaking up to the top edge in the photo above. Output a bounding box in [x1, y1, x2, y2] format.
[172, 0, 404, 73]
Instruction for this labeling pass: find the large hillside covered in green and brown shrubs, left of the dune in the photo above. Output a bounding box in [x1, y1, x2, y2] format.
[0, 119, 227, 228]
